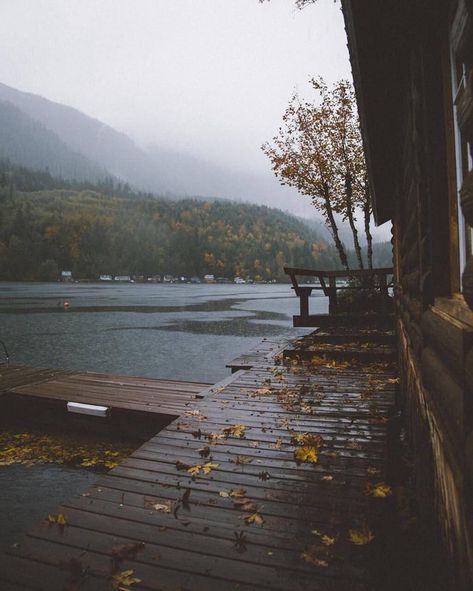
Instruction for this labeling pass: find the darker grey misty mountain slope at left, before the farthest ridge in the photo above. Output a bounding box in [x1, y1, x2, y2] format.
[0, 101, 107, 181]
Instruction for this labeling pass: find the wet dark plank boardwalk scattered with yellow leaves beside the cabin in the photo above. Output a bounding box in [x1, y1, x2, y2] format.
[0, 330, 396, 591]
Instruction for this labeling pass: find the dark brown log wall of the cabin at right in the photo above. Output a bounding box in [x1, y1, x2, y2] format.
[393, 4, 473, 589]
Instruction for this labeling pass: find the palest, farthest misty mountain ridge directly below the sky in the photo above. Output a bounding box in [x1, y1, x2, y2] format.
[0, 84, 314, 210]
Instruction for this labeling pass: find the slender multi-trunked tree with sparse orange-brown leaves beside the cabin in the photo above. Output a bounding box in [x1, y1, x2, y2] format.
[262, 78, 372, 269]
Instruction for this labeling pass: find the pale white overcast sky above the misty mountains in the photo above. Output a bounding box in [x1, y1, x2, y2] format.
[0, 0, 350, 170]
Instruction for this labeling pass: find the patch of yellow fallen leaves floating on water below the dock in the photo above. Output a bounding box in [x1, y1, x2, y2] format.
[0, 431, 134, 470]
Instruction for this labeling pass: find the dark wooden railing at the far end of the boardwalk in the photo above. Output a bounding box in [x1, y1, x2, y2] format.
[284, 267, 393, 326]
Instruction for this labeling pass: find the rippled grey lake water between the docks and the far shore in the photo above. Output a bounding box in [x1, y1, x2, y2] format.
[0, 282, 327, 382]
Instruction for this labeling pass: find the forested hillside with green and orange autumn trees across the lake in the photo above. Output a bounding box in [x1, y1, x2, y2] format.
[0, 172, 335, 280]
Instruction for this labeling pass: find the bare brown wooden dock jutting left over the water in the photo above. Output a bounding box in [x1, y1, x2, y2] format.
[0, 366, 211, 416]
